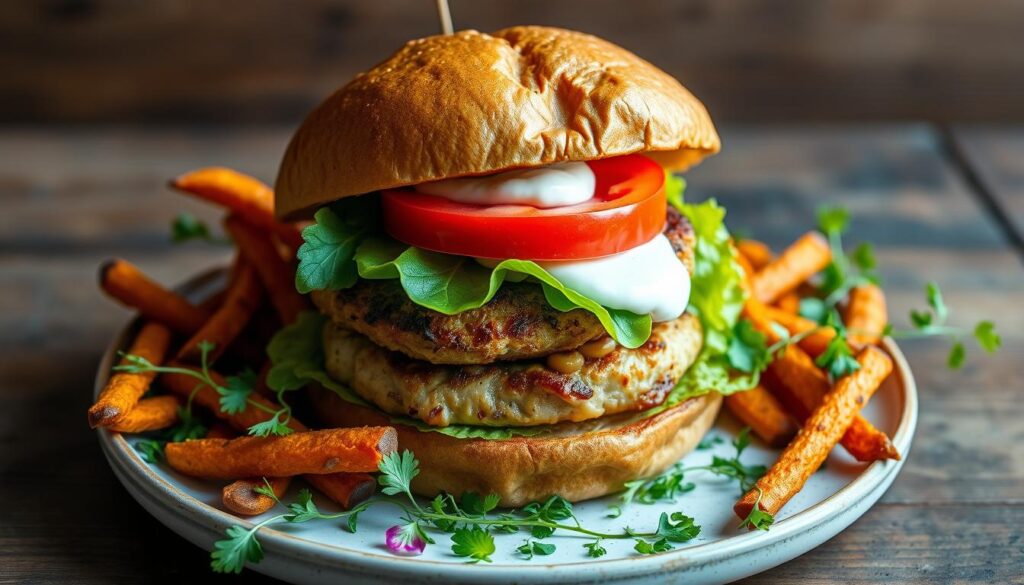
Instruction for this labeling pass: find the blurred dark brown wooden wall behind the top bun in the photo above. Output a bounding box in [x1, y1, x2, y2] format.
[0, 0, 1024, 124]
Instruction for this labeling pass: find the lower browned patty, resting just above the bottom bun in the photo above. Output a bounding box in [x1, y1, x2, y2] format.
[324, 314, 703, 426]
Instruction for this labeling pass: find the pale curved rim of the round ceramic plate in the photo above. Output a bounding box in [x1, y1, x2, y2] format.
[93, 268, 919, 581]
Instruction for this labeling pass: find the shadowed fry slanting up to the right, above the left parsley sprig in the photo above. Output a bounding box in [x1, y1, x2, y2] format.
[177, 261, 263, 364]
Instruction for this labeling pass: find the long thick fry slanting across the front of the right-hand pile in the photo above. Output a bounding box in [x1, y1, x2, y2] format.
[733, 346, 893, 518]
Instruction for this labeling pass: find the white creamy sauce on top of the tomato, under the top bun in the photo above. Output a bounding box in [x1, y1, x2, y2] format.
[416, 162, 596, 208]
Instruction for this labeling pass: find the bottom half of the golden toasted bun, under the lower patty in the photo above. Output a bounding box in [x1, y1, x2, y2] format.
[309, 387, 722, 506]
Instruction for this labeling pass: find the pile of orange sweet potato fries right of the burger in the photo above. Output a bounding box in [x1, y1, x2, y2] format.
[725, 232, 900, 518]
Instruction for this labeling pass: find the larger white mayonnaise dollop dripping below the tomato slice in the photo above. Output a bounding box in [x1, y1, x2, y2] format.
[538, 234, 690, 322]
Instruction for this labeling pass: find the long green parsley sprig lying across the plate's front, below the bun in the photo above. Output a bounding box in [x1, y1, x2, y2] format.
[211, 451, 700, 573]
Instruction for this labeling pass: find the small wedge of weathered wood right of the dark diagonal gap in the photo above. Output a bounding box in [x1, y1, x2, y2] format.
[952, 126, 1024, 246]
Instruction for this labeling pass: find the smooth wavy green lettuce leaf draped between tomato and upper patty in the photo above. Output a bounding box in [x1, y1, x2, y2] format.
[355, 238, 651, 348]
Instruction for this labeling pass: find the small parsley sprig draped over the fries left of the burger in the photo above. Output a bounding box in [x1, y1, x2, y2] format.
[114, 341, 292, 436]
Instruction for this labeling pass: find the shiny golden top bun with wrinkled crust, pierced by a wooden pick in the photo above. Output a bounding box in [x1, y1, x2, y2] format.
[275, 27, 719, 217]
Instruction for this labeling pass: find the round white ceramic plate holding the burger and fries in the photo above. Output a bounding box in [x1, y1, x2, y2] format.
[95, 273, 918, 583]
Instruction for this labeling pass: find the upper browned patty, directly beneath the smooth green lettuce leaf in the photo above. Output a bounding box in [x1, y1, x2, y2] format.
[312, 207, 694, 364]
